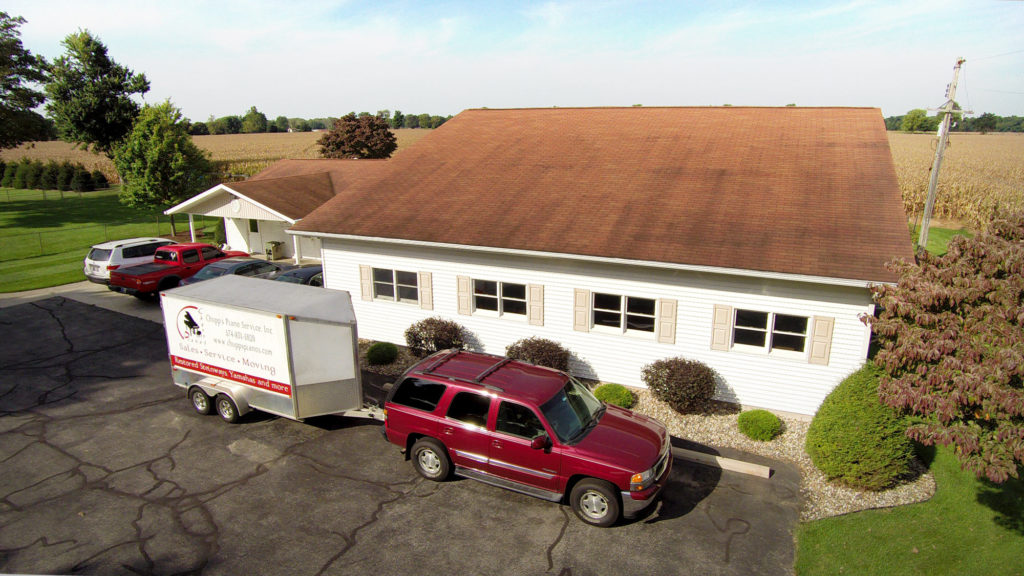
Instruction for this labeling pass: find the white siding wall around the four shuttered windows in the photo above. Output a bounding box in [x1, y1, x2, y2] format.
[323, 239, 872, 414]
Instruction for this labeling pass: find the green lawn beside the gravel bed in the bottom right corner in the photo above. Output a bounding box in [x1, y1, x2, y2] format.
[796, 448, 1024, 576]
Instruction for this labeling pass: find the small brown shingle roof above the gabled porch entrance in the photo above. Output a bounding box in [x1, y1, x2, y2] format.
[224, 159, 385, 219]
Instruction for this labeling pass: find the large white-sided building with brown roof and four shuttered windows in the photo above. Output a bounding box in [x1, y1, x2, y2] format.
[167, 107, 912, 414]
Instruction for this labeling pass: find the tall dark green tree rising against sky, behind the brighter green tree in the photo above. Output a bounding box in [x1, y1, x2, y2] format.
[46, 30, 150, 157]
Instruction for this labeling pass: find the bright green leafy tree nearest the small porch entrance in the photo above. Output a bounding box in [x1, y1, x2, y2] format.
[114, 100, 210, 230]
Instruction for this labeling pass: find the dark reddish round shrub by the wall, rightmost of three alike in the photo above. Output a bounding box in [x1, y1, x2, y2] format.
[641, 358, 715, 413]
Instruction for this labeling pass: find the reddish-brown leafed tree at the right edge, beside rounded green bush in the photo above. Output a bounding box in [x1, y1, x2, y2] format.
[866, 212, 1024, 483]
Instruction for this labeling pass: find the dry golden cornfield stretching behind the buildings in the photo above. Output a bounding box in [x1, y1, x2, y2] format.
[0, 128, 1024, 230]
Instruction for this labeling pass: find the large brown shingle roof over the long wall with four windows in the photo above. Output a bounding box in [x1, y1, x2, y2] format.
[294, 107, 911, 281]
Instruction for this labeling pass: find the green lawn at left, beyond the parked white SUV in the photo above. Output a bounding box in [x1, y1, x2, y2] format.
[0, 188, 215, 292]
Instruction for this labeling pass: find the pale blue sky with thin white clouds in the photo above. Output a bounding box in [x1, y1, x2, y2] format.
[8, 0, 1024, 121]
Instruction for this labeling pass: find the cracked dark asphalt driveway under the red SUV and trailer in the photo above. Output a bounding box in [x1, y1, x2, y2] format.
[0, 297, 799, 576]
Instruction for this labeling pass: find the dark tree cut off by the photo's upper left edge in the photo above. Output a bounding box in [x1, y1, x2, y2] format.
[0, 11, 46, 149]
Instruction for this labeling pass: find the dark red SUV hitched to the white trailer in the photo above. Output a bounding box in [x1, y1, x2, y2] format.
[384, 349, 672, 527]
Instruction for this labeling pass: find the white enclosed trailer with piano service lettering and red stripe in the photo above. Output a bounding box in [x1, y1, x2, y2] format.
[161, 276, 384, 422]
